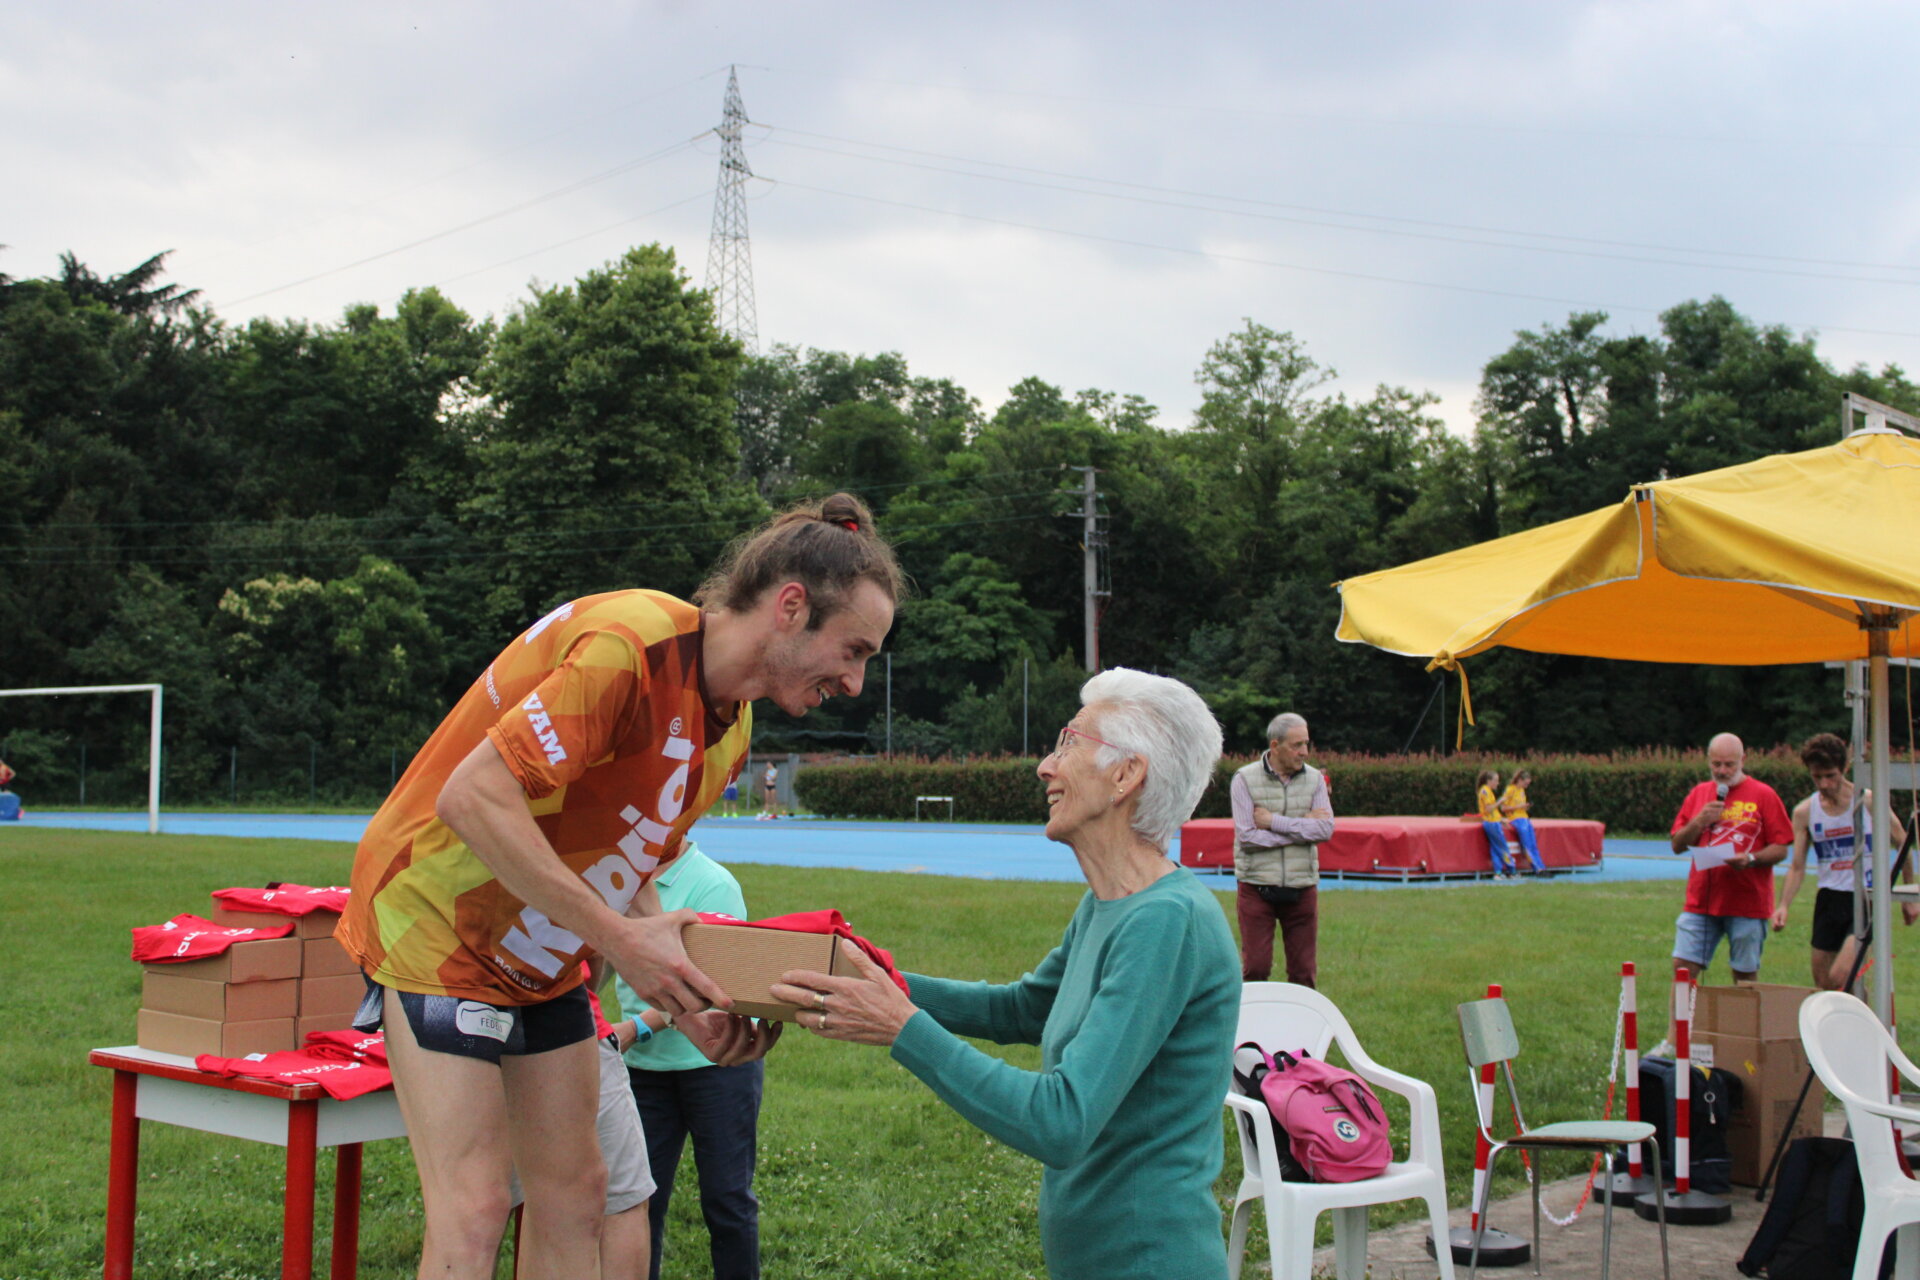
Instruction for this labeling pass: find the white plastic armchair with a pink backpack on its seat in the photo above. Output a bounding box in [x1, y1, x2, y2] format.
[1227, 983, 1453, 1280]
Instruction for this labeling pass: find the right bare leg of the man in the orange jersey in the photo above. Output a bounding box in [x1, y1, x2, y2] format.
[499, 1038, 607, 1280]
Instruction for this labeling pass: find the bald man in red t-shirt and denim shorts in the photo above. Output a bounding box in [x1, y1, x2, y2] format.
[1672, 733, 1793, 983]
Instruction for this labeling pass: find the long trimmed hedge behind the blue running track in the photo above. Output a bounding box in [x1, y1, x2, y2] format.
[793, 748, 1912, 833]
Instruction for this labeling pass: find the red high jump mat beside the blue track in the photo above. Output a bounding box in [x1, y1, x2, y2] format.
[1181, 818, 1607, 879]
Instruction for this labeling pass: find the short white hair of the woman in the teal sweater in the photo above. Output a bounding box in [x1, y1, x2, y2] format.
[1081, 666, 1221, 850]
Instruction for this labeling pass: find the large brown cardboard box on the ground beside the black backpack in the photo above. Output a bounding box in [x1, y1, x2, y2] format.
[1693, 983, 1826, 1186]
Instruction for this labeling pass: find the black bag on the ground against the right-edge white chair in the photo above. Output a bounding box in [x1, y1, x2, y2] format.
[1738, 1138, 1895, 1280]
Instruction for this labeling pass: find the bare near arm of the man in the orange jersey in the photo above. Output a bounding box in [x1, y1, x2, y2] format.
[434, 741, 728, 1015]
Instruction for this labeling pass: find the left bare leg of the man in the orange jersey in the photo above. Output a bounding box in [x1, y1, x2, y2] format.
[384, 990, 513, 1280]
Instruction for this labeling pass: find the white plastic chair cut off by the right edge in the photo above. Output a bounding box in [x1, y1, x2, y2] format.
[1801, 990, 1920, 1280]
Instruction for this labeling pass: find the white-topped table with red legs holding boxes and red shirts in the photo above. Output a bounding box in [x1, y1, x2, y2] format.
[86, 1046, 407, 1280]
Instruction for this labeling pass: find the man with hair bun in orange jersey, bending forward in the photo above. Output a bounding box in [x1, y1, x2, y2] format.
[336, 493, 904, 1280]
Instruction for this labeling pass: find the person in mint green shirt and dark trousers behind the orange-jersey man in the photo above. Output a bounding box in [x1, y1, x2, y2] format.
[614, 841, 766, 1280]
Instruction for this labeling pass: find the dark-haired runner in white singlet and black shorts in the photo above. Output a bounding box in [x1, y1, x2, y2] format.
[1774, 733, 1920, 990]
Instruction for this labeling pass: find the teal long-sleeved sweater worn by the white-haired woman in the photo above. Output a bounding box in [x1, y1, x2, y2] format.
[893, 871, 1240, 1280]
